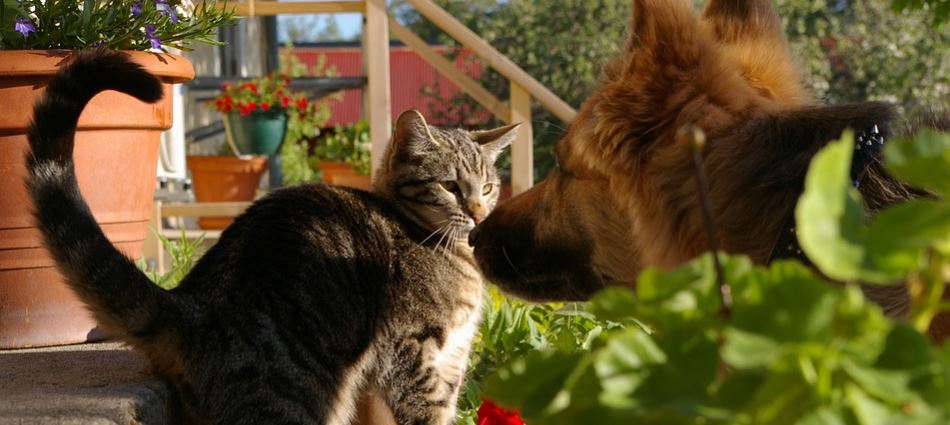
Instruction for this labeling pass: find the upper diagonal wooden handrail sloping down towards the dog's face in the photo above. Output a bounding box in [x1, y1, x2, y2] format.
[406, 0, 577, 123]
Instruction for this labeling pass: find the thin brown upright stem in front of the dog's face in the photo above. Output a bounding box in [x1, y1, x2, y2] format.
[679, 125, 732, 318]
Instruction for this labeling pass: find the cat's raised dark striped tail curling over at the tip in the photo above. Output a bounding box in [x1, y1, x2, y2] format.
[26, 49, 186, 343]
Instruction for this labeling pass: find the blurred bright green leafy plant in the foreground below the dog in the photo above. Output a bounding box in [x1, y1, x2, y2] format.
[484, 132, 950, 425]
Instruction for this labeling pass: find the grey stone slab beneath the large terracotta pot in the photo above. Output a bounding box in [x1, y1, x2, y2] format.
[0, 343, 175, 425]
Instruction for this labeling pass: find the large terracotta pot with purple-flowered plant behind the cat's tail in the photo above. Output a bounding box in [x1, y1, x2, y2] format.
[0, 0, 232, 348]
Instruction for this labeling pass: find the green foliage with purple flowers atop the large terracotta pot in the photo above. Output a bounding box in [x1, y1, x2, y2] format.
[0, 0, 234, 50]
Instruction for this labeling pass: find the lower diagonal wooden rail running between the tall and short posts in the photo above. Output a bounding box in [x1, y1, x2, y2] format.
[389, 17, 511, 122]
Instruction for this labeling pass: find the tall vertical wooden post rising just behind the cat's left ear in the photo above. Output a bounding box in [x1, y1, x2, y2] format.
[363, 0, 392, 180]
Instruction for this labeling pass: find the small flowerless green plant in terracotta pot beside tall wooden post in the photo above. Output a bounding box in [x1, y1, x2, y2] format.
[314, 120, 370, 189]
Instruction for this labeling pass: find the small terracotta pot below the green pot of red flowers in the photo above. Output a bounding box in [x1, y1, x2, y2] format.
[187, 155, 267, 230]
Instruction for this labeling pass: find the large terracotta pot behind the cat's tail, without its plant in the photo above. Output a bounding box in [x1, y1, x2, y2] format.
[0, 50, 194, 348]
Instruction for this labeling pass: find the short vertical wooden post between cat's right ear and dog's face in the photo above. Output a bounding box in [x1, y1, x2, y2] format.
[509, 81, 534, 195]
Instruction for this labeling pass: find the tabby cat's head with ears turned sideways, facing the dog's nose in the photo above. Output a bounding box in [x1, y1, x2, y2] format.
[374, 109, 518, 240]
